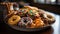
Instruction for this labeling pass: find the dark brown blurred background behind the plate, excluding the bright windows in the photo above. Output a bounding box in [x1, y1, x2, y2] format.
[0, 0, 60, 14]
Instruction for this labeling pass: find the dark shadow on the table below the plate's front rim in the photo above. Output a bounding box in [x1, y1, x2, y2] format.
[0, 26, 54, 34]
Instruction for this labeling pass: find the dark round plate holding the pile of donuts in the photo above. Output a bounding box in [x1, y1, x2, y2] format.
[3, 3, 54, 31]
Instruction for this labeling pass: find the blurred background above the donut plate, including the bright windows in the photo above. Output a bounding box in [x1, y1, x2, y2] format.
[0, 0, 60, 14]
